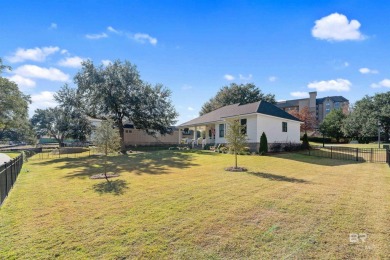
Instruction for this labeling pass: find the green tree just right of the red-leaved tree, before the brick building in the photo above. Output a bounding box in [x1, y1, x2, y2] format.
[319, 108, 346, 142]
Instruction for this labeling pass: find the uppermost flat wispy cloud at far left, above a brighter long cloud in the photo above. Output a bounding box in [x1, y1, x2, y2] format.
[6, 46, 60, 63]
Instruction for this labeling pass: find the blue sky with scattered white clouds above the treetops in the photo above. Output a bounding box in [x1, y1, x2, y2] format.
[0, 0, 390, 123]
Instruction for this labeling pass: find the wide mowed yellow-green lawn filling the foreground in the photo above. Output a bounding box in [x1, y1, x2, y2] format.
[0, 151, 390, 259]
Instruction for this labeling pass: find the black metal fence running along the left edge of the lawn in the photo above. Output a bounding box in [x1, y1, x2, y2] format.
[0, 155, 23, 205]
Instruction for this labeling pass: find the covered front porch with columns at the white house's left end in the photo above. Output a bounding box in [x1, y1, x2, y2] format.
[178, 123, 216, 147]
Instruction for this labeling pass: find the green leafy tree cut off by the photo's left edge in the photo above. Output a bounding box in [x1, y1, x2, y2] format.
[0, 59, 32, 143]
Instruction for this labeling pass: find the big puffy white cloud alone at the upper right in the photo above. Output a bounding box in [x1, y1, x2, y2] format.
[311, 13, 365, 41]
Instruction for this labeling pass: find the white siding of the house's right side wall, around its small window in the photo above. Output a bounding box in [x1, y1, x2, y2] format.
[257, 114, 300, 143]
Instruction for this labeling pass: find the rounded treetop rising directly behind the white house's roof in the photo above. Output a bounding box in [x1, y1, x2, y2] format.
[199, 83, 276, 115]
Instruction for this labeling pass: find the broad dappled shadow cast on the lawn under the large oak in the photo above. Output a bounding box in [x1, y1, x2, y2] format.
[34, 150, 197, 178]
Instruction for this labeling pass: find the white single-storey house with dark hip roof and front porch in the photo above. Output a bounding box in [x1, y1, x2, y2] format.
[179, 101, 302, 150]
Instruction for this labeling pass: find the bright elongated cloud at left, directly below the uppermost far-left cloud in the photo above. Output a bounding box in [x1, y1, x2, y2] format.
[13, 65, 69, 81]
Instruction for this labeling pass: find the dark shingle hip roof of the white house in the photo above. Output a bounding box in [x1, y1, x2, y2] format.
[180, 101, 300, 126]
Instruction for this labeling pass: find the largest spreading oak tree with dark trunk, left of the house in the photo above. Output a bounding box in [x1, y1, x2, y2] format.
[75, 60, 178, 153]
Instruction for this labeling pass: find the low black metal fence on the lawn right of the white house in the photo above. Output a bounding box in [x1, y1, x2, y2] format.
[302, 146, 390, 165]
